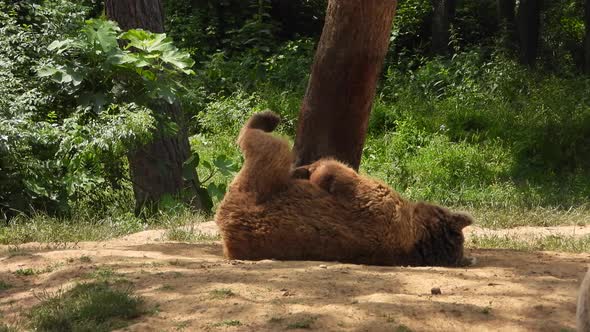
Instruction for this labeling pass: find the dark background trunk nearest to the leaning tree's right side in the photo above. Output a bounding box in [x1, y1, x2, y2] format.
[431, 0, 455, 55]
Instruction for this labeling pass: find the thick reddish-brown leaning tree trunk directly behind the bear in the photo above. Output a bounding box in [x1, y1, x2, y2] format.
[295, 0, 397, 169]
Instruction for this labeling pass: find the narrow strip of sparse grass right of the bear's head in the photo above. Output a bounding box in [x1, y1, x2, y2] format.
[466, 235, 590, 253]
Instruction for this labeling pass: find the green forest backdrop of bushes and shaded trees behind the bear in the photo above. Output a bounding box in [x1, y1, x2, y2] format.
[0, 0, 590, 228]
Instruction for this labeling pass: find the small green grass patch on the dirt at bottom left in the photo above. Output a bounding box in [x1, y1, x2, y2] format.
[29, 282, 143, 332]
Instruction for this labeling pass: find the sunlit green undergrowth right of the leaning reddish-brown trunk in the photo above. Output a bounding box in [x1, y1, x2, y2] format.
[364, 49, 590, 206]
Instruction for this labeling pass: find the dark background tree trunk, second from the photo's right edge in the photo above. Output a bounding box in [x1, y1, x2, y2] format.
[518, 0, 541, 66]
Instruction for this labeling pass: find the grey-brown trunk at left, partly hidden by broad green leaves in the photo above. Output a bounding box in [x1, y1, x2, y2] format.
[105, 0, 207, 212]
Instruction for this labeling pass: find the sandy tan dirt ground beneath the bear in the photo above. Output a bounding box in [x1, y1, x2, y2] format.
[0, 224, 590, 331]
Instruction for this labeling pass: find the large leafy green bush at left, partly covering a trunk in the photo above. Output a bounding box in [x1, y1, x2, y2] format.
[0, 1, 193, 218]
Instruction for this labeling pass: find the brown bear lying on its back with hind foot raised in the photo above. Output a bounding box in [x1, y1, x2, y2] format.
[215, 111, 472, 266]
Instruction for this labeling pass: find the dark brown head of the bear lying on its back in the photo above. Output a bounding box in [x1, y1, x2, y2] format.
[411, 203, 474, 266]
